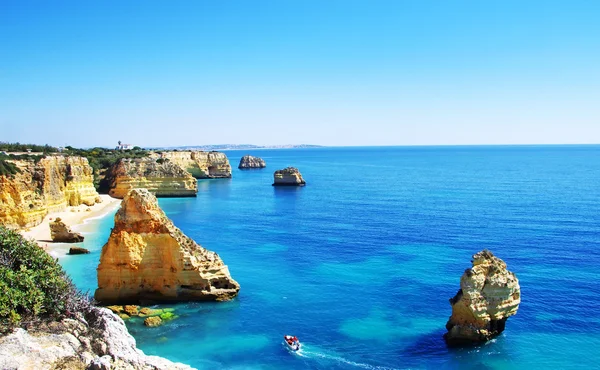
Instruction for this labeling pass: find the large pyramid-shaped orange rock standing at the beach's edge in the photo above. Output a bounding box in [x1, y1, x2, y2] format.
[95, 189, 240, 304]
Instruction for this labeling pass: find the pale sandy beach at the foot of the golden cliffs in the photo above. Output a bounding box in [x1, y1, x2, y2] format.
[21, 194, 121, 246]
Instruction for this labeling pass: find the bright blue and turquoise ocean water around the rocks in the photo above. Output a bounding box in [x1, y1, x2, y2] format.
[60, 146, 600, 369]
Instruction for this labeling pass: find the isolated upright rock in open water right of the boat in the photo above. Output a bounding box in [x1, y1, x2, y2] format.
[444, 250, 521, 346]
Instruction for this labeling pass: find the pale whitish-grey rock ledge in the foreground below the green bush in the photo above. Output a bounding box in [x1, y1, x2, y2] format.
[0, 308, 191, 370]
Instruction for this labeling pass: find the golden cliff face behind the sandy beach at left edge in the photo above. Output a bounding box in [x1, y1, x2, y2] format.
[0, 155, 100, 227]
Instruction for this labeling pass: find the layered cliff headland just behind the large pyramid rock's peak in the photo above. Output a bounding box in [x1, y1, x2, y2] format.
[107, 158, 198, 198]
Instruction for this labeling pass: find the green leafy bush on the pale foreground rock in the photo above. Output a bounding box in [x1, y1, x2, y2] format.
[0, 225, 92, 333]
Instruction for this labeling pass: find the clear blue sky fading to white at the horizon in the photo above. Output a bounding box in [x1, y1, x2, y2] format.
[0, 0, 600, 147]
